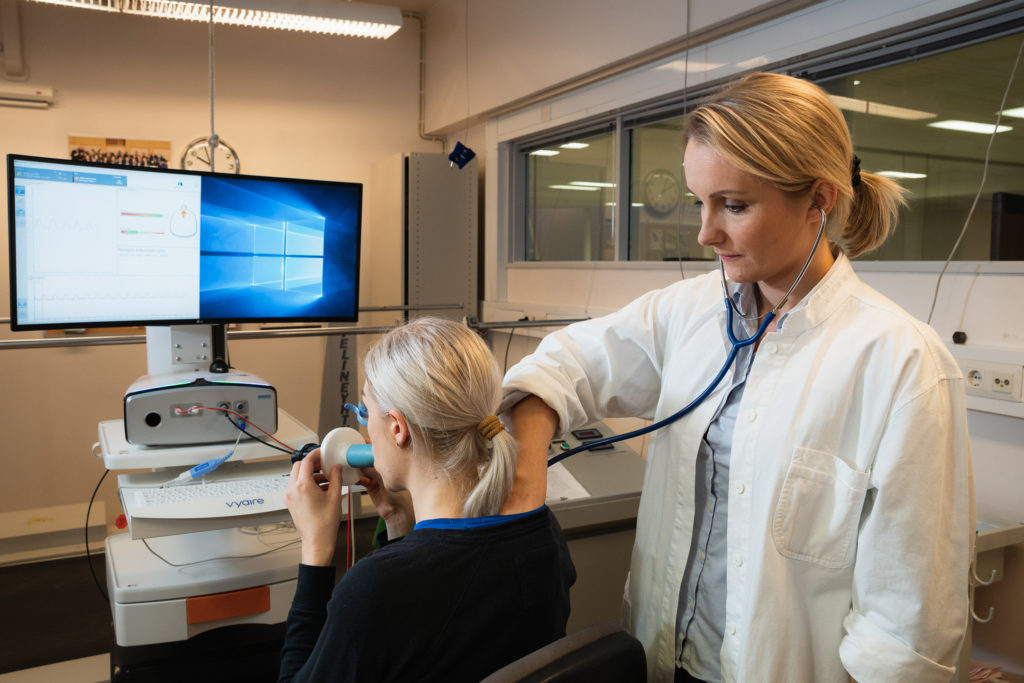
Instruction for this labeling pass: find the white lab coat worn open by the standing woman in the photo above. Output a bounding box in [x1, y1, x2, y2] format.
[505, 254, 975, 683]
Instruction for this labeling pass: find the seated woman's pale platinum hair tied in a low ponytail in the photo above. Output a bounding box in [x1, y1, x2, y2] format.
[365, 317, 516, 517]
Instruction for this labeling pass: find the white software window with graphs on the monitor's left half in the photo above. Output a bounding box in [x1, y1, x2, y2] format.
[26, 179, 199, 323]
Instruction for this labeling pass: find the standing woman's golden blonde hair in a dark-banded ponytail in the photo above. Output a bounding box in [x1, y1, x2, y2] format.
[684, 73, 906, 257]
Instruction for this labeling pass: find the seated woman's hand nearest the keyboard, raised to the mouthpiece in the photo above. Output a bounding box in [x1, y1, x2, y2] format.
[285, 449, 341, 566]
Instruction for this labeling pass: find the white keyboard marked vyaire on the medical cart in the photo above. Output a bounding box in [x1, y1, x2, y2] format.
[121, 473, 288, 519]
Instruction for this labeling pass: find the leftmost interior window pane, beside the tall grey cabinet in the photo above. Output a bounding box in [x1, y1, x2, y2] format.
[524, 133, 615, 261]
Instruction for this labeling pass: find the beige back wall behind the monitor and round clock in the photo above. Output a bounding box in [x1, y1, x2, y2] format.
[0, 3, 439, 532]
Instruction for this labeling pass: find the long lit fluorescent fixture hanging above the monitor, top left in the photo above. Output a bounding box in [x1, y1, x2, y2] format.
[28, 0, 401, 38]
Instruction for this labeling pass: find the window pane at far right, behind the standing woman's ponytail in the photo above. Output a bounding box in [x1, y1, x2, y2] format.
[819, 28, 1024, 261]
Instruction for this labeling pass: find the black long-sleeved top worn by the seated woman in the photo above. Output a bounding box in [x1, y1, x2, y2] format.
[279, 507, 575, 683]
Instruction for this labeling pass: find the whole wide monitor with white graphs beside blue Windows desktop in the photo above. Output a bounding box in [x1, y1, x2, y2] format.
[7, 155, 362, 330]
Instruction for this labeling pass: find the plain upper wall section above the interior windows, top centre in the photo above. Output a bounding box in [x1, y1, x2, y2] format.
[426, 0, 818, 131]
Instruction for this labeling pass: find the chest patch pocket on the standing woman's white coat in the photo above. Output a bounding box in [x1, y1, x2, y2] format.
[772, 449, 868, 568]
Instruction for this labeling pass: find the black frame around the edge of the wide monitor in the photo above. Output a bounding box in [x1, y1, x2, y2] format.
[6, 154, 364, 332]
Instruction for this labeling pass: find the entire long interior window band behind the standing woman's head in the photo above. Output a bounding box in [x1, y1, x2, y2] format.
[516, 11, 1024, 261]
